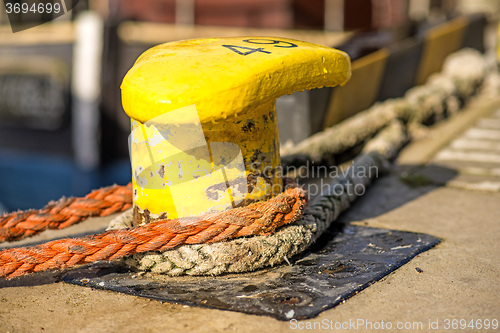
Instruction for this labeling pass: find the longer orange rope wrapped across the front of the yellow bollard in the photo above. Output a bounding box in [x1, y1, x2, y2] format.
[0, 187, 307, 278]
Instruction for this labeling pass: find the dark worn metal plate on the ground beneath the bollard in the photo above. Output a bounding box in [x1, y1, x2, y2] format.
[62, 225, 439, 320]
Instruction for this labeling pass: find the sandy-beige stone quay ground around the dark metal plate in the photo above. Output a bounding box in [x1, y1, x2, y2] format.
[0, 94, 500, 332]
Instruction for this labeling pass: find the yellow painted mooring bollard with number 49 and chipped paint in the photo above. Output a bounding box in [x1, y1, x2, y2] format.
[121, 37, 351, 224]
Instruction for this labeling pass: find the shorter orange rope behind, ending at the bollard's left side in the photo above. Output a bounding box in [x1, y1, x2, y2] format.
[0, 184, 132, 243]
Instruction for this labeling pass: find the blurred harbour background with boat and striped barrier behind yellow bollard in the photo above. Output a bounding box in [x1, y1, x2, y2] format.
[0, 0, 500, 212]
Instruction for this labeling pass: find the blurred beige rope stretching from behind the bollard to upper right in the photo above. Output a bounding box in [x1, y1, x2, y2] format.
[282, 49, 488, 166]
